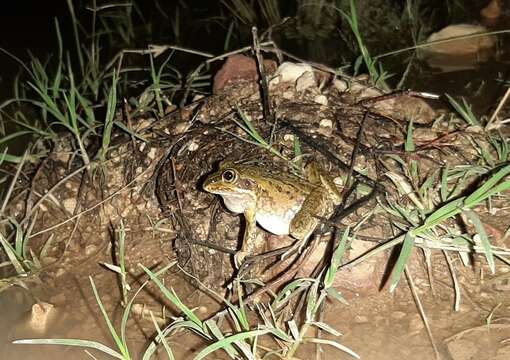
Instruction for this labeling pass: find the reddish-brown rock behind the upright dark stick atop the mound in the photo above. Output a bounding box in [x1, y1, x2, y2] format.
[213, 54, 276, 94]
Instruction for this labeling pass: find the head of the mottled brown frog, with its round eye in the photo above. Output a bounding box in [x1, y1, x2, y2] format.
[202, 161, 256, 197]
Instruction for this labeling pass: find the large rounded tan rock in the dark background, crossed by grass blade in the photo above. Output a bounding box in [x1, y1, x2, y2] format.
[423, 24, 496, 55]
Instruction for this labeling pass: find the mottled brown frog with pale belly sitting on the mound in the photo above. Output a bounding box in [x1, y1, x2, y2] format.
[202, 160, 342, 268]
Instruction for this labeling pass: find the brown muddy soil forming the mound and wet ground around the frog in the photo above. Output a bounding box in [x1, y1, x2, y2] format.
[0, 57, 510, 360]
